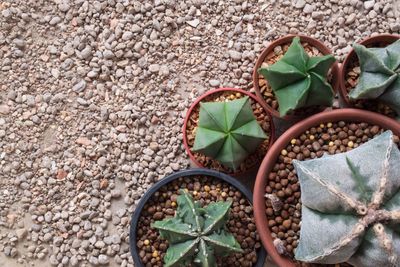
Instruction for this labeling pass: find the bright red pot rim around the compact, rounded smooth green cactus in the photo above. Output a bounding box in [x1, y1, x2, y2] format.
[182, 88, 275, 176]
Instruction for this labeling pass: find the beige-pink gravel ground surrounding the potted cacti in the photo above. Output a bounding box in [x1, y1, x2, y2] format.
[0, 0, 400, 267]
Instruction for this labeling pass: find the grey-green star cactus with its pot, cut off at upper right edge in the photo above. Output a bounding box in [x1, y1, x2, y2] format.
[340, 34, 400, 117]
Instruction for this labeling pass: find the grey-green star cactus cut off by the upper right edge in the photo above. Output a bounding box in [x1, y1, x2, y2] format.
[349, 40, 400, 115]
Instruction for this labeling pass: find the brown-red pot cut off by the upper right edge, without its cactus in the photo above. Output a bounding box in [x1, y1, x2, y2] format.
[339, 34, 400, 107]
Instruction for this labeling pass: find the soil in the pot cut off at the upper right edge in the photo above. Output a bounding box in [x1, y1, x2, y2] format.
[345, 43, 397, 118]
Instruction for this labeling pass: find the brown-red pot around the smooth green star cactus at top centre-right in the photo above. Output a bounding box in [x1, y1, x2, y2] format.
[253, 34, 339, 121]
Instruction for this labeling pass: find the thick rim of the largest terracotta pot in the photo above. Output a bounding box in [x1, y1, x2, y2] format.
[253, 109, 400, 267]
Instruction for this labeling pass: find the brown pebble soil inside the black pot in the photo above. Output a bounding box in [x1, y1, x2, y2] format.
[136, 176, 261, 267]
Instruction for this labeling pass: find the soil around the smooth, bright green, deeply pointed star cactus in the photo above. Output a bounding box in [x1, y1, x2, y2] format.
[258, 42, 332, 116]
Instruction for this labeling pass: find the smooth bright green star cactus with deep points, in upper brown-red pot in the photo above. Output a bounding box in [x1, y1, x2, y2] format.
[258, 37, 336, 116]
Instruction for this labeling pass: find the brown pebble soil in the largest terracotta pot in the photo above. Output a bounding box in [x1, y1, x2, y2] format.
[265, 121, 399, 266]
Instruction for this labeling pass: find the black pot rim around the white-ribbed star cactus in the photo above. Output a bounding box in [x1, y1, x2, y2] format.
[129, 168, 267, 267]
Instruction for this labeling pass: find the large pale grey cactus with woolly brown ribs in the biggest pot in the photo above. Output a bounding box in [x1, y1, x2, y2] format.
[293, 131, 400, 267]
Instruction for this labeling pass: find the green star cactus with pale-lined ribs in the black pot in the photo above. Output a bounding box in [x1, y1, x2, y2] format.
[152, 190, 243, 267]
